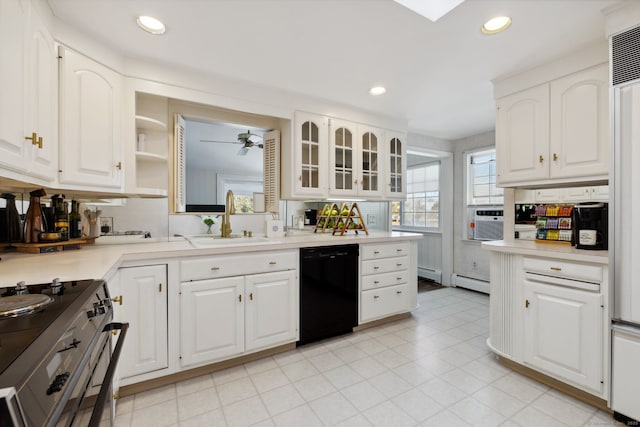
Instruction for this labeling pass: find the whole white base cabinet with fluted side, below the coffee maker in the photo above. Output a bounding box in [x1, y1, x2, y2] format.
[488, 251, 609, 399]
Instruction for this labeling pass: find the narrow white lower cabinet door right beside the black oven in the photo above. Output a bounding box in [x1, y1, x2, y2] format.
[118, 264, 168, 379]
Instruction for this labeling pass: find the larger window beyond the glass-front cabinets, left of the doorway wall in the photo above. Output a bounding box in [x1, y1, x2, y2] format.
[391, 162, 440, 229]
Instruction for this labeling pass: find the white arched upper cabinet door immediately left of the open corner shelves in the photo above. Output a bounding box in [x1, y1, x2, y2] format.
[59, 46, 124, 190]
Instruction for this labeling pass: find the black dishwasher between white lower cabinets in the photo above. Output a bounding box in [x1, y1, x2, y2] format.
[298, 245, 358, 345]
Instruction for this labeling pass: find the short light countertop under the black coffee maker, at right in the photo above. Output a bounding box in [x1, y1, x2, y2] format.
[482, 240, 609, 265]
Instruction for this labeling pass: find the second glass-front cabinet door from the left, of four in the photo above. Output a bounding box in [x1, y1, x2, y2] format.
[329, 119, 358, 196]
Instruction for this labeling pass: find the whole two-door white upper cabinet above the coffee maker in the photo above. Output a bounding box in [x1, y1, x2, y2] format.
[496, 64, 609, 187]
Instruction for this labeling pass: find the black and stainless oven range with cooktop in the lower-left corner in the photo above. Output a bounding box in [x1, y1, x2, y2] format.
[0, 280, 128, 427]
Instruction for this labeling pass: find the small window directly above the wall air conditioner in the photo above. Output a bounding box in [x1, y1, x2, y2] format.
[467, 149, 504, 206]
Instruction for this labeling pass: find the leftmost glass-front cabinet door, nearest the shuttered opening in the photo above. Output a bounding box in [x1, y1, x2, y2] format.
[294, 112, 328, 197]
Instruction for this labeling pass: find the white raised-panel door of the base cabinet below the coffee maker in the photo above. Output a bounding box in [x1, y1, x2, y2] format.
[524, 281, 604, 393]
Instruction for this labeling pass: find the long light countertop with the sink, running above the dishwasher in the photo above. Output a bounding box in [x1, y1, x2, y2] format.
[0, 232, 422, 288]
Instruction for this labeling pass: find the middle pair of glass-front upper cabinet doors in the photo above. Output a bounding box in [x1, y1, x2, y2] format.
[329, 119, 384, 199]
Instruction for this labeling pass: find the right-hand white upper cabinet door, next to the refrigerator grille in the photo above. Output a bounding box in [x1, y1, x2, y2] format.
[549, 64, 609, 179]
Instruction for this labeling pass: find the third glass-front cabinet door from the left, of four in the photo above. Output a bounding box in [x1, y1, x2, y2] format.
[356, 125, 384, 198]
